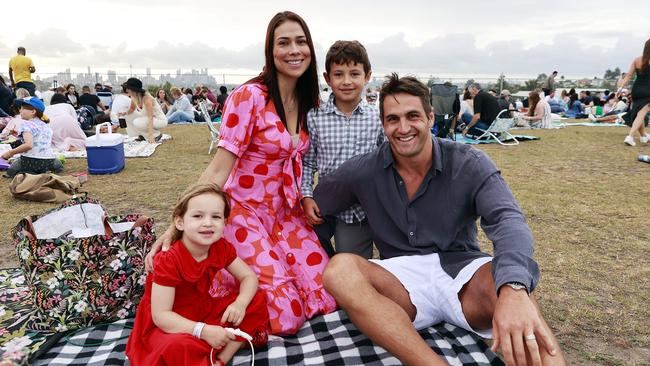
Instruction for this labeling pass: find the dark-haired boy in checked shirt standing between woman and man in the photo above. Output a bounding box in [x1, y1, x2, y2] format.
[301, 41, 384, 258]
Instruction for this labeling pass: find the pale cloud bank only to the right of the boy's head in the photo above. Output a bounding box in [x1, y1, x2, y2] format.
[366, 34, 645, 77]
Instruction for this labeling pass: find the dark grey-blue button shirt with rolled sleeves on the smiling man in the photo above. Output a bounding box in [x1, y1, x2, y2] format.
[314, 138, 539, 291]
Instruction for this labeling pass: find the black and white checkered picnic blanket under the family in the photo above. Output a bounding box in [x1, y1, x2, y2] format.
[33, 311, 503, 366]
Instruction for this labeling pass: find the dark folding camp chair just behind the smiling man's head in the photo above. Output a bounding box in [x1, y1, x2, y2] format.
[431, 84, 460, 140]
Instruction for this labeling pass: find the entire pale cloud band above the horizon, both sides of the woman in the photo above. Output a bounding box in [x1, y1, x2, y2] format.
[22, 29, 645, 78]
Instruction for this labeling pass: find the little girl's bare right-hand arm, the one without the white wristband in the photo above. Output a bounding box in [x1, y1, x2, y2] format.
[221, 258, 257, 326]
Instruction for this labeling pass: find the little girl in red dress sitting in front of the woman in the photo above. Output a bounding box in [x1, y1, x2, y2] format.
[126, 184, 269, 366]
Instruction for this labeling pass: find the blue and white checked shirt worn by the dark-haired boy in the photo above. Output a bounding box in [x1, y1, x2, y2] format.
[301, 93, 385, 224]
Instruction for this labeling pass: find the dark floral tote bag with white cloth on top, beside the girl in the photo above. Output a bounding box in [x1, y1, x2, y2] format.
[12, 198, 155, 332]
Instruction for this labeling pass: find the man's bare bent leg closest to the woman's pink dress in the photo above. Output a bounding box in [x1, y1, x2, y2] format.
[323, 253, 447, 365]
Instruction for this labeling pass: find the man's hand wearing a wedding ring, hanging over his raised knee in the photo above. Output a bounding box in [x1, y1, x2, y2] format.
[492, 286, 557, 366]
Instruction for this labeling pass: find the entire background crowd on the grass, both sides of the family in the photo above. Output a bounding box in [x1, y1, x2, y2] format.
[0, 39, 648, 167]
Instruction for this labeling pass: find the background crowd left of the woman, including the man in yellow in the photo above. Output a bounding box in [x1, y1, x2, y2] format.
[0, 47, 237, 156]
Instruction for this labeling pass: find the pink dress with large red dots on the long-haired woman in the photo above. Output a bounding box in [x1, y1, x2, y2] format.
[211, 84, 336, 334]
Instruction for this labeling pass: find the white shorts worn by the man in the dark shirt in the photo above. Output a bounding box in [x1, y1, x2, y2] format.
[371, 253, 492, 338]
